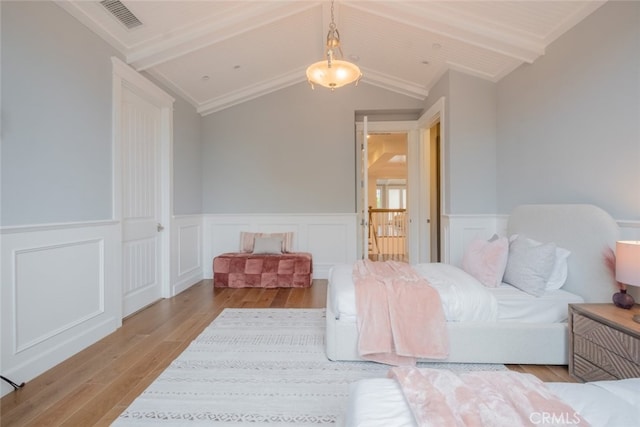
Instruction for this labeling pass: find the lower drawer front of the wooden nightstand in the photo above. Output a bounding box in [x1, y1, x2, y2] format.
[573, 335, 640, 381]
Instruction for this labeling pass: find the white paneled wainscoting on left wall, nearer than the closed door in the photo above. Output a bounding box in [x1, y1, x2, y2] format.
[0, 221, 122, 395]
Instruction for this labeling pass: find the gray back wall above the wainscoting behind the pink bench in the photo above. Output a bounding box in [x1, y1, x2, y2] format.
[202, 83, 423, 213]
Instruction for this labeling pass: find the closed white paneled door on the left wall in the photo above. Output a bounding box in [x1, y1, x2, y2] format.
[120, 86, 163, 316]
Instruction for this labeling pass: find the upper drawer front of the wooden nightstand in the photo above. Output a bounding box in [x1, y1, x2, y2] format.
[572, 313, 640, 364]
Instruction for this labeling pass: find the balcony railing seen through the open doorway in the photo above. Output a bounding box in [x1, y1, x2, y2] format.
[369, 207, 408, 262]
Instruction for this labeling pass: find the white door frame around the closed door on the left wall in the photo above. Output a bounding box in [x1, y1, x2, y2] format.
[111, 57, 175, 317]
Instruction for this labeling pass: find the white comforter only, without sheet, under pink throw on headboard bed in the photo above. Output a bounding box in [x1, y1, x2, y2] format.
[329, 263, 498, 322]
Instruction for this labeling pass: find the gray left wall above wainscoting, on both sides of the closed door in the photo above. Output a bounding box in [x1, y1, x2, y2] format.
[0, 1, 202, 226]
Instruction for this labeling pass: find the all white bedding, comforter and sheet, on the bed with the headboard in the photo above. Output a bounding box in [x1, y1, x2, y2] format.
[329, 263, 584, 323]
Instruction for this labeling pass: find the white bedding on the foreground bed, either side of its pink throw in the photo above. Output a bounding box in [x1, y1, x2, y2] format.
[345, 378, 640, 427]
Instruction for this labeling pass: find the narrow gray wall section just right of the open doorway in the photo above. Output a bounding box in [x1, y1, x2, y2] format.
[425, 71, 497, 214]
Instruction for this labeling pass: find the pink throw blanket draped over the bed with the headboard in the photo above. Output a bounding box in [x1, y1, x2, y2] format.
[353, 260, 449, 365]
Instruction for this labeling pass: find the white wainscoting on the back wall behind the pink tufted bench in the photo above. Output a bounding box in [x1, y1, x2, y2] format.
[203, 214, 357, 279]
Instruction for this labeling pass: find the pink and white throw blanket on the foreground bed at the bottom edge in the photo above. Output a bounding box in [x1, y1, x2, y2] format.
[389, 367, 589, 427]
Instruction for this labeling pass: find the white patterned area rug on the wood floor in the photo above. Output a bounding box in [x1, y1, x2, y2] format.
[113, 309, 506, 427]
